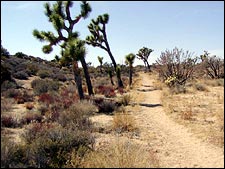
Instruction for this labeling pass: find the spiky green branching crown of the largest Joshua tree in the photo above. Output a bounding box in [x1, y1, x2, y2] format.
[33, 1, 91, 53]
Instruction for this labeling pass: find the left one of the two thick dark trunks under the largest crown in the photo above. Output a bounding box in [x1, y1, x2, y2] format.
[73, 62, 84, 100]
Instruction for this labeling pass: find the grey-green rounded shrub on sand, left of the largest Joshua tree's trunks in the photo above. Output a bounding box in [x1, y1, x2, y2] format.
[31, 79, 59, 95]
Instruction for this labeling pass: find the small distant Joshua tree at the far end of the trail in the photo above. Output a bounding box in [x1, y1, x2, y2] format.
[136, 47, 153, 71]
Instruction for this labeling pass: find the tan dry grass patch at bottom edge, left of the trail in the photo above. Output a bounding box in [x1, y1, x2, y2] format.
[83, 141, 159, 168]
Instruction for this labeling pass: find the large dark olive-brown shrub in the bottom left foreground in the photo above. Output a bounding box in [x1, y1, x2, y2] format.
[24, 123, 94, 168]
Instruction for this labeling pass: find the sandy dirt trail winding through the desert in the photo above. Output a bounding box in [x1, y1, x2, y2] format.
[131, 73, 224, 168]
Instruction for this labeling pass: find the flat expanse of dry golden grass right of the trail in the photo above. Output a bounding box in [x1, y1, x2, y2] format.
[161, 79, 224, 147]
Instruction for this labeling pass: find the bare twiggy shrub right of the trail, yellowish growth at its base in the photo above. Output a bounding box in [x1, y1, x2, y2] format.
[156, 48, 197, 87]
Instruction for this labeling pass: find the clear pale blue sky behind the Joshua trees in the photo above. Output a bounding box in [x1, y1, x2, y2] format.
[1, 1, 224, 66]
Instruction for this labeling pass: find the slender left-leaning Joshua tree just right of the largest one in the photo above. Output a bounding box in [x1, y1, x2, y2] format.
[86, 14, 123, 87]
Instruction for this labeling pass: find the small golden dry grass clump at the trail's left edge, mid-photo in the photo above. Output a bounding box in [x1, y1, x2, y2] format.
[112, 111, 137, 133]
